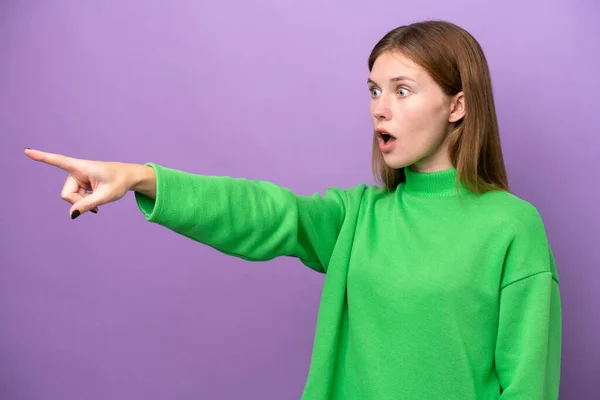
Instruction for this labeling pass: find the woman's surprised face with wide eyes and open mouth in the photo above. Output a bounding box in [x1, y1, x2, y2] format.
[368, 52, 465, 172]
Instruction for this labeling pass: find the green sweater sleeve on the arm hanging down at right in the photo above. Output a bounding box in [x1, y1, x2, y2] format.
[496, 208, 562, 400]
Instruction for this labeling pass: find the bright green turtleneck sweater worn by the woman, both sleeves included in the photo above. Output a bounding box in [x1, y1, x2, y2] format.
[136, 163, 561, 400]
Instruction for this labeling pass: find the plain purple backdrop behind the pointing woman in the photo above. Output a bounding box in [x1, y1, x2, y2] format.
[0, 0, 600, 400]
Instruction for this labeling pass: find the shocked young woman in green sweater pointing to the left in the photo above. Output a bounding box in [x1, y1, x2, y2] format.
[26, 21, 561, 400]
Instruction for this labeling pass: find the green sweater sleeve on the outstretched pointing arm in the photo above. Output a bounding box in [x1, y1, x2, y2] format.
[129, 163, 347, 272]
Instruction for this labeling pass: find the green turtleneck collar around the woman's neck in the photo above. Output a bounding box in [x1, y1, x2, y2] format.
[404, 167, 464, 197]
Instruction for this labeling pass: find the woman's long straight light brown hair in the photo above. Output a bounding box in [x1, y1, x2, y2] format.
[369, 21, 509, 193]
